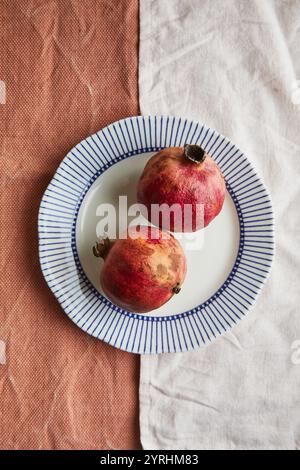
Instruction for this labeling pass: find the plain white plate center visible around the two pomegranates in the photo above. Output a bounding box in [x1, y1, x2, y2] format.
[76, 152, 240, 316]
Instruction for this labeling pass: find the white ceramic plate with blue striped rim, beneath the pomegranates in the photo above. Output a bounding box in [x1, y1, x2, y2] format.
[39, 116, 274, 354]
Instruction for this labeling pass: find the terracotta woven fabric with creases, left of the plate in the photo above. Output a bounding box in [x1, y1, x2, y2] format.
[0, 0, 140, 449]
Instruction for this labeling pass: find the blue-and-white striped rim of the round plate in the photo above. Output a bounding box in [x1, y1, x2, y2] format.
[38, 116, 274, 354]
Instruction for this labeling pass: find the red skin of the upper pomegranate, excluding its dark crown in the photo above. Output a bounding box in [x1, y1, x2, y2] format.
[137, 147, 226, 232]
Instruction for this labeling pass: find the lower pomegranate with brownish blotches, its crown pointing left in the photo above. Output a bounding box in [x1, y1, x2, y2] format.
[93, 226, 186, 313]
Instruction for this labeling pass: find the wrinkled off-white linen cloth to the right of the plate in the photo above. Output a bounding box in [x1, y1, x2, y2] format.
[139, 0, 300, 449]
